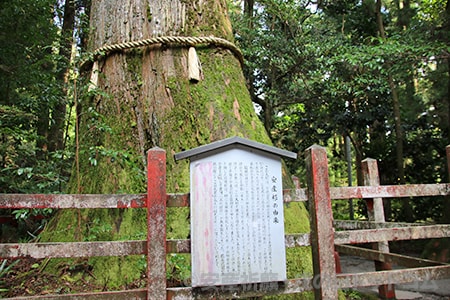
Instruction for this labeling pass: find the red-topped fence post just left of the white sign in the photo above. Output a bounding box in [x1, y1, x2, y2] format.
[147, 147, 166, 300]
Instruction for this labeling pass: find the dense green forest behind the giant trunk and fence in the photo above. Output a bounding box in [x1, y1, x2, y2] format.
[0, 0, 450, 292]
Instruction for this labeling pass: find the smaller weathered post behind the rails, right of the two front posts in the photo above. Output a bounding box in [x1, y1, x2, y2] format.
[362, 158, 395, 299]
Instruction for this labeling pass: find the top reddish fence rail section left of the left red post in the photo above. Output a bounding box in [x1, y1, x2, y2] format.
[0, 194, 147, 209]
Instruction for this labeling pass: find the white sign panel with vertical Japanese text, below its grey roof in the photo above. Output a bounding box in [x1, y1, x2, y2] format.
[191, 149, 286, 287]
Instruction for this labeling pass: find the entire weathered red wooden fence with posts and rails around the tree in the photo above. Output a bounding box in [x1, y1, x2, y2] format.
[0, 146, 450, 300]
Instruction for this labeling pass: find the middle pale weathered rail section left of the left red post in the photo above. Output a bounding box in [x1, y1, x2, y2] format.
[0, 241, 147, 259]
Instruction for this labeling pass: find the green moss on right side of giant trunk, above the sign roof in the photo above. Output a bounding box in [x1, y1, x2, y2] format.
[161, 49, 270, 192]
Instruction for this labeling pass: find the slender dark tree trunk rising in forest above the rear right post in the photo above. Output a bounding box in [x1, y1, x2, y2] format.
[376, 0, 414, 222]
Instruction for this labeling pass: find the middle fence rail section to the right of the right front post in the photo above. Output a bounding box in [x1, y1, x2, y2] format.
[334, 225, 450, 245]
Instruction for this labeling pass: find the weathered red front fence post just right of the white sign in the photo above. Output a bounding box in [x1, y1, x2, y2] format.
[306, 145, 338, 300]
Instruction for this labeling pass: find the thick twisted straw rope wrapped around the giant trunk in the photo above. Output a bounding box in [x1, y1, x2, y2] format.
[89, 36, 244, 65]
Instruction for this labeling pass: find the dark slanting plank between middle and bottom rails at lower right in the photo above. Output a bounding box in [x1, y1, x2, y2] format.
[336, 245, 446, 268]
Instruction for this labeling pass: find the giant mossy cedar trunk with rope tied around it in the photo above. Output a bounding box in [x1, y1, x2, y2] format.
[43, 0, 311, 287]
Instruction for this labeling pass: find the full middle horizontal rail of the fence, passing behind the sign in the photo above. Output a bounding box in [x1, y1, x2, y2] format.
[0, 225, 450, 258]
